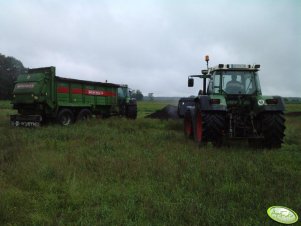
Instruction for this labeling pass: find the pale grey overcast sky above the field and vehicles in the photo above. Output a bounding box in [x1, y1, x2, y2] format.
[0, 0, 301, 96]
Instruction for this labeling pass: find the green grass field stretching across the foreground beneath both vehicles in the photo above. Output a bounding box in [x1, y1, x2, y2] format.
[0, 102, 301, 226]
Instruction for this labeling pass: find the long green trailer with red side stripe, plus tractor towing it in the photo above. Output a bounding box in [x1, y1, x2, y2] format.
[10, 67, 137, 127]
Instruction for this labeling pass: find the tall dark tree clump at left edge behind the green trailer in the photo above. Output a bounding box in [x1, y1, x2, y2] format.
[0, 53, 24, 100]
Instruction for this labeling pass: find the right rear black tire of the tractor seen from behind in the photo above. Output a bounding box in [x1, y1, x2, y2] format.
[262, 112, 285, 148]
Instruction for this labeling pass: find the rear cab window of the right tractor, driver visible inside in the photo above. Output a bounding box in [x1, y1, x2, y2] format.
[213, 71, 260, 94]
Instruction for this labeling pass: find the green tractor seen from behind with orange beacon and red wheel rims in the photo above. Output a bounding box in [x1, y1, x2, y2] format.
[184, 56, 285, 148]
